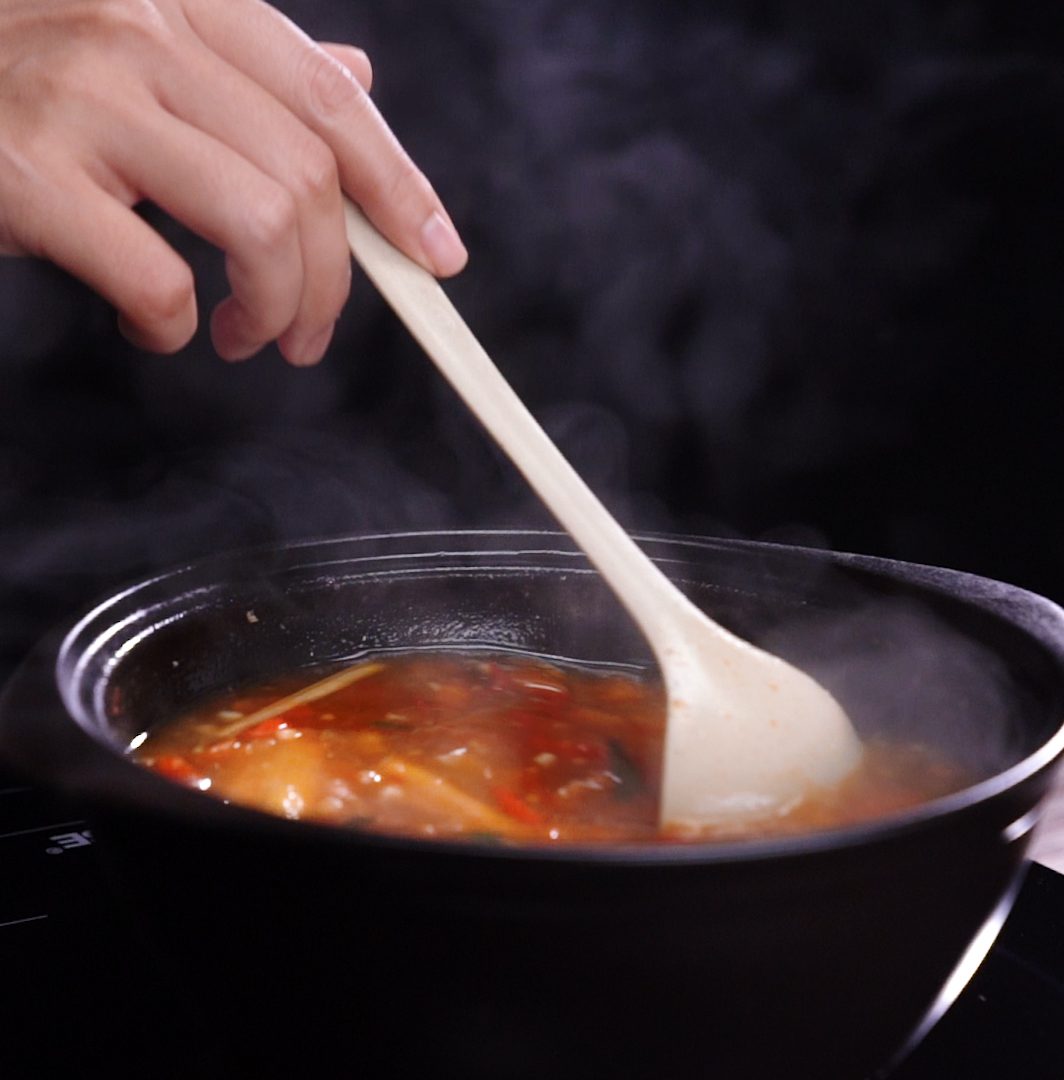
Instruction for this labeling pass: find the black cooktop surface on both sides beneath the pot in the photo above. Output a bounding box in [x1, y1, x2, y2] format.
[0, 772, 1064, 1080]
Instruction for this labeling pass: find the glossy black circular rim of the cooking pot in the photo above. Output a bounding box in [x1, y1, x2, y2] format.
[20, 529, 1064, 866]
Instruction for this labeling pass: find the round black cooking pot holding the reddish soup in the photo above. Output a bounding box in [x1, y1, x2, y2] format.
[0, 532, 1064, 1080]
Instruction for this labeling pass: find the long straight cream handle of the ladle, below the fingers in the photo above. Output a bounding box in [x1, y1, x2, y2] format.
[345, 200, 682, 638]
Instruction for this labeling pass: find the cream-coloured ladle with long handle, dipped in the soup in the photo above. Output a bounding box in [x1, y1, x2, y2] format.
[346, 202, 861, 825]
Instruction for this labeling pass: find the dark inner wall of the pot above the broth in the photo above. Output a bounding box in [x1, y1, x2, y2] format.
[76, 548, 1060, 779]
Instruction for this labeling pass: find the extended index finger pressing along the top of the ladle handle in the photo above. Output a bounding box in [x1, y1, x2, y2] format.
[185, 0, 468, 278]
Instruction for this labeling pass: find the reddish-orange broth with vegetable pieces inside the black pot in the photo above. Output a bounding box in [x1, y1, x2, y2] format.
[134, 652, 967, 843]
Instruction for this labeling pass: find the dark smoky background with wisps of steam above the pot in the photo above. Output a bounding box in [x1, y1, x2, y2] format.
[0, 0, 1064, 675]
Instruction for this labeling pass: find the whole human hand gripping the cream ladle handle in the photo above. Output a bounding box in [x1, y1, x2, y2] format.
[0, 0, 466, 364]
